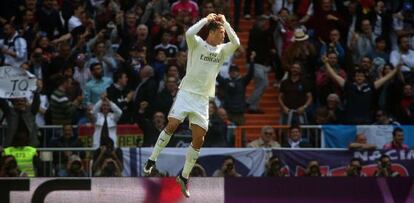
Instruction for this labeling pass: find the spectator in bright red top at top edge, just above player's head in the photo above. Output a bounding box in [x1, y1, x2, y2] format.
[171, 0, 199, 23]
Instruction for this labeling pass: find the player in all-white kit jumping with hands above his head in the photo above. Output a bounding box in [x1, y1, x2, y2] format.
[143, 13, 240, 197]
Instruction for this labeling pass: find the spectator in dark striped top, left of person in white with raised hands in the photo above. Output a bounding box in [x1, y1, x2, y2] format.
[50, 75, 83, 125]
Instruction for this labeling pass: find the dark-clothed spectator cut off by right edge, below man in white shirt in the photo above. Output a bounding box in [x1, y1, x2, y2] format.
[396, 84, 414, 124]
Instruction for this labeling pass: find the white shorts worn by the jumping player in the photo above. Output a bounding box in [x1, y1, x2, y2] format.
[168, 90, 209, 131]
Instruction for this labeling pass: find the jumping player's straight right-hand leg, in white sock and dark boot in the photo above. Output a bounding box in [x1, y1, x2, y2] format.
[177, 124, 207, 197]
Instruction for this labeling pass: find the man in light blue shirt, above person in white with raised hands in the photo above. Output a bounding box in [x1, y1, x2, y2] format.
[84, 63, 112, 109]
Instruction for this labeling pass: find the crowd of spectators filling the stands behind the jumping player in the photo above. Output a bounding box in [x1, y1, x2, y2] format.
[0, 0, 414, 176]
